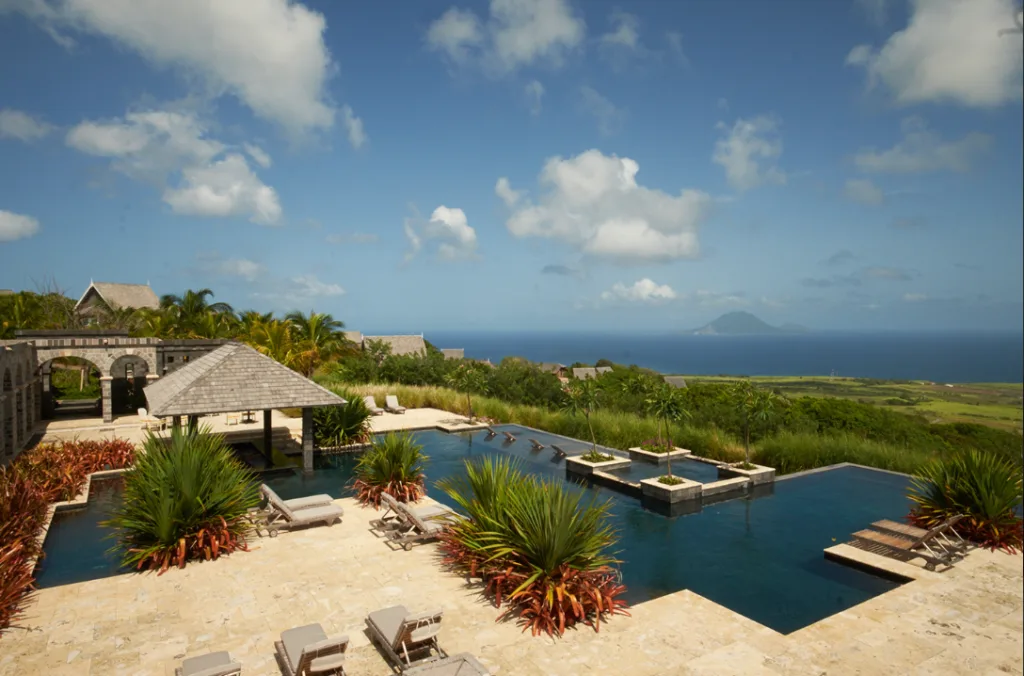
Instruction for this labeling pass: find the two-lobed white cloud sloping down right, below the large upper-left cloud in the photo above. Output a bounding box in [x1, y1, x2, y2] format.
[66, 111, 282, 225]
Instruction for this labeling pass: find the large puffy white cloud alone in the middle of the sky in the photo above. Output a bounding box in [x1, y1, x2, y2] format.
[499, 150, 712, 261]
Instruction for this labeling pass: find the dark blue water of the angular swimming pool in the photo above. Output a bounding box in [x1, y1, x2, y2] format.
[38, 425, 909, 633]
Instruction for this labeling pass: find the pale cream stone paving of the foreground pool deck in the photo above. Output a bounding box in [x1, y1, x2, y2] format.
[0, 491, 1024, 676]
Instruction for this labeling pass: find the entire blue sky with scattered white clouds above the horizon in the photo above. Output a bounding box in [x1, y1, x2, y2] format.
[0, 0, 1024, 333]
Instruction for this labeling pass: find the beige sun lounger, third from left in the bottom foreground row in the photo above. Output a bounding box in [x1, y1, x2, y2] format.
[367, 605, 447, 671]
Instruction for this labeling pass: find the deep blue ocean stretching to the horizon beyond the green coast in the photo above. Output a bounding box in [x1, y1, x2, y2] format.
[426, 331, 1024, 383]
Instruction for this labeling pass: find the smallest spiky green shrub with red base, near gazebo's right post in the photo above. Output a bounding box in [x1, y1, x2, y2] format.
[352, 432, 427, 507]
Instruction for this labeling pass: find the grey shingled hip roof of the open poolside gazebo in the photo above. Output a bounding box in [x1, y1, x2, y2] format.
[143, 343, 347, 417]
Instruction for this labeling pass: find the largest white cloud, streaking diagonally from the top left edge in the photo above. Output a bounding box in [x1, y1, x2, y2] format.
[19, 0, 335, 134]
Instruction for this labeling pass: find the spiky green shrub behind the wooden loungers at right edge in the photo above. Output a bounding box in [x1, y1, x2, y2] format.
[910, 450, 1024, 551]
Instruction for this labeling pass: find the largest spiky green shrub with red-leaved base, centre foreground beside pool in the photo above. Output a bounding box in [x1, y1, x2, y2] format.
[439, 457, 627, 636]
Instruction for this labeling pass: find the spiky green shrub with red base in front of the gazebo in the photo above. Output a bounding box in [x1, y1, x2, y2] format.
[105, 426, 259, 575]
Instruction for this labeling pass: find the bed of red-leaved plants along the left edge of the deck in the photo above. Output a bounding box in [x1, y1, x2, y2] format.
[0, 439, 135, 631]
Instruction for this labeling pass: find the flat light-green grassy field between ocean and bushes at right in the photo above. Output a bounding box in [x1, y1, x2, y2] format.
[667, 376, 1022, 430]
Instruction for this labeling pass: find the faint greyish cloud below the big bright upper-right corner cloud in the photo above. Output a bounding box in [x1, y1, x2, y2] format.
[853, 117, 992, 174]
